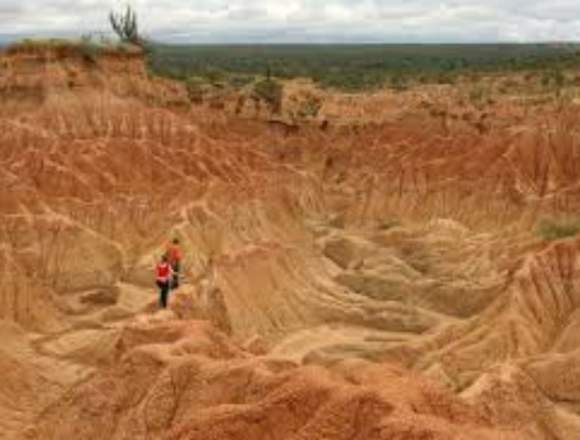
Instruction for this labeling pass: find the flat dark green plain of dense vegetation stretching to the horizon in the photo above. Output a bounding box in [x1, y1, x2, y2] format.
[150, 44, 580, 90]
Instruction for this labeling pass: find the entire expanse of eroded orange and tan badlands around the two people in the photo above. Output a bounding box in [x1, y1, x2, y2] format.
[0, 44, 580, 440]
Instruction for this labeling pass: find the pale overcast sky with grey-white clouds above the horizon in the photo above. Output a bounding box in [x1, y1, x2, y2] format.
[0, 0, 580, 43]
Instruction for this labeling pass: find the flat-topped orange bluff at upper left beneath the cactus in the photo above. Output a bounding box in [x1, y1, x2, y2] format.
[0, 41, 187, 112]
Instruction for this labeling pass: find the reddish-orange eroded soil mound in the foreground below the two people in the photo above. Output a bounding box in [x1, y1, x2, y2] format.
[20, 321, 525, 439]
